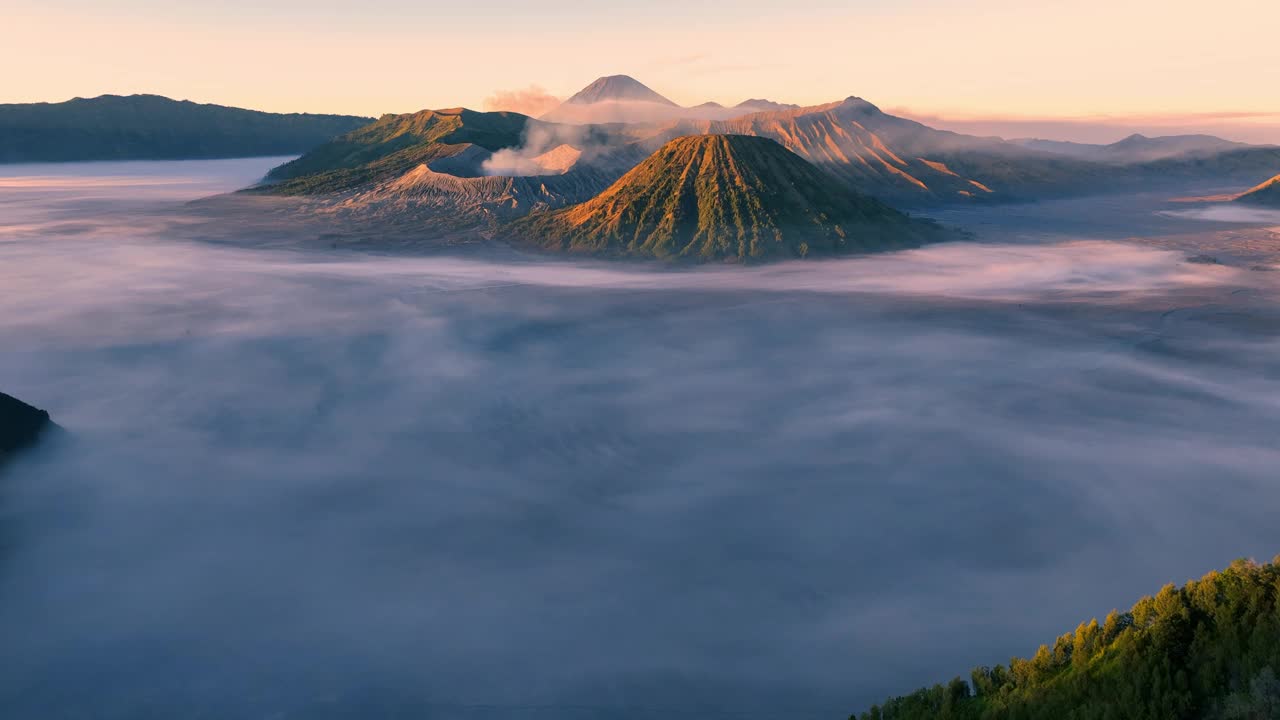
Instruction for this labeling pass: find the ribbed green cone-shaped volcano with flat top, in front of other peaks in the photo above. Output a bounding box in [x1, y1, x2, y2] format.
[509, 135, 943, 261]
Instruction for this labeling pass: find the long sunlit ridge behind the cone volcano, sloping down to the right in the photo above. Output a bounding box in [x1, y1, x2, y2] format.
[631, 97, 1280, 205]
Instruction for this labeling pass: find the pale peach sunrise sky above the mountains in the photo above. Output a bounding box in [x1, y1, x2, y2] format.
[0, 0, 1280, 142]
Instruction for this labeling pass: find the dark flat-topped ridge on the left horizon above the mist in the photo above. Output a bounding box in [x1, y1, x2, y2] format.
[0, 95, 371, 163]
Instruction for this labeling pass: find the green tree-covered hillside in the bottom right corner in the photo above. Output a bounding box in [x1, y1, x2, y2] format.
[851, 557, 1280, 720]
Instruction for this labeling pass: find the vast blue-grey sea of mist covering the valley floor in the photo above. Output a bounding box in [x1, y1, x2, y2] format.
[0, 160, 1280, 720]
